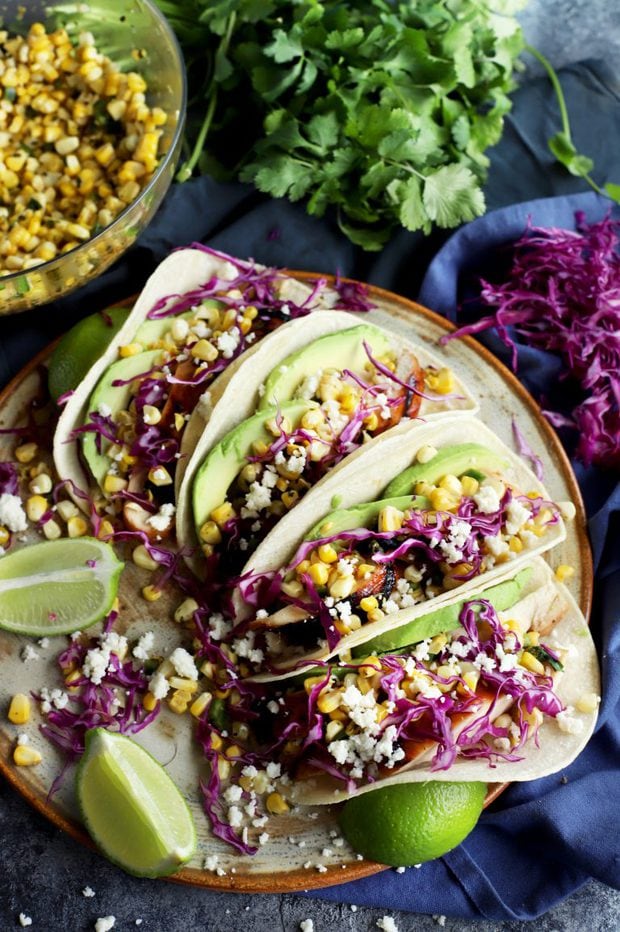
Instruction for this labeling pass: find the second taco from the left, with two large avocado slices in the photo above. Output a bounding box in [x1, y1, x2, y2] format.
[182, 312, 477, 578]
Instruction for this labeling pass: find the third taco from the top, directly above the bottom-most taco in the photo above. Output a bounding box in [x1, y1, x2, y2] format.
[229, 416, 574, 678]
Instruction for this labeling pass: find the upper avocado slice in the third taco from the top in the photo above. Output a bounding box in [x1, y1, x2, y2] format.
[383, 443, 508, 498]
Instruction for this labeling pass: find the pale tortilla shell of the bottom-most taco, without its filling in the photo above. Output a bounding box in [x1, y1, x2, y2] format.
[293, 559, 601, 806]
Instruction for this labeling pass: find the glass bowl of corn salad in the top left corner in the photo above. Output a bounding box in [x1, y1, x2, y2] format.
[0, 0, 185, 314]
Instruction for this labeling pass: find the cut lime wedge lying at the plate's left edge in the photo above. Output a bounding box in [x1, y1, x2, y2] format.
[0, 537, 124, 637]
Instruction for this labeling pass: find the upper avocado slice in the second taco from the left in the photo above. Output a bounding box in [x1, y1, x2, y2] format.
[259, 324, 391, 410]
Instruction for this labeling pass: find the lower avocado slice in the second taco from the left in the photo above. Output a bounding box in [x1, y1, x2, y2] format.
[192, 400, 310, 528]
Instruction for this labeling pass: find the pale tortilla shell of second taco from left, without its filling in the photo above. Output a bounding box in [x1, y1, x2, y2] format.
[175, 314, 478, 575]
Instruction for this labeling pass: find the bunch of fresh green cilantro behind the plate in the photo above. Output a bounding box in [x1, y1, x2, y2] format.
[157, 0, 523, 250]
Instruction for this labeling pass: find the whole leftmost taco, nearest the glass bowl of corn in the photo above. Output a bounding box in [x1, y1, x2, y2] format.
[54, 246, 368, 538]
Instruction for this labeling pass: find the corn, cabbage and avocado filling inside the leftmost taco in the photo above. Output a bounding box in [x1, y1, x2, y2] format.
[69, 251, 366, 539]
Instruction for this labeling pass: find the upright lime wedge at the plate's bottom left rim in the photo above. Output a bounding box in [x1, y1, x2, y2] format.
[76, 728, 196, 877]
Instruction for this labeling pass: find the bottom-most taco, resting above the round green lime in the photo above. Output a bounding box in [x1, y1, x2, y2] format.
[253, 558, 600, 805]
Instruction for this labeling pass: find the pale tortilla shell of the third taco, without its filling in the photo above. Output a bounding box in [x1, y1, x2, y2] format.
[233, 414, 566, 679]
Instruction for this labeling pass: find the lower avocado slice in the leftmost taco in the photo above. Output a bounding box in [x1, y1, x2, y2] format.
[82, 350, 161, 486]
